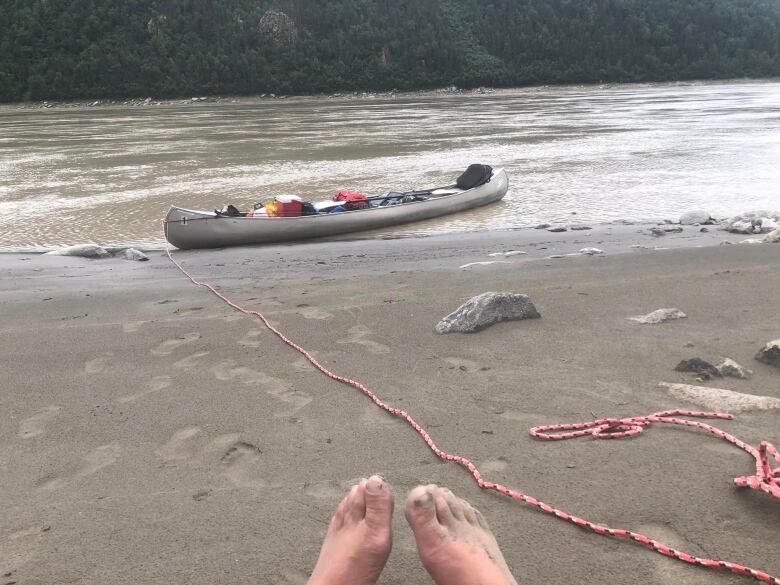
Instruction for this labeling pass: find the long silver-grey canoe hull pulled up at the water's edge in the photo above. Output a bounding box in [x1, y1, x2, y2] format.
[165, 169, 509, 249]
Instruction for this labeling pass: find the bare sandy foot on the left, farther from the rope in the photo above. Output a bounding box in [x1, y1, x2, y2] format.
[309, 475, 393, 585]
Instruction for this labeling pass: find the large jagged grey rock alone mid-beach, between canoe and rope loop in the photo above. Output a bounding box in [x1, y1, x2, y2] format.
[436, 292, 541, 334]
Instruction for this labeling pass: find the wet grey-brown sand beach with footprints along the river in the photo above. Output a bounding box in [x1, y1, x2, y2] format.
[0, 226, 780, 585]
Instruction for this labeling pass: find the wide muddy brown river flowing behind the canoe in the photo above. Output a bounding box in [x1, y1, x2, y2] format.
[0, 80, 780, 250]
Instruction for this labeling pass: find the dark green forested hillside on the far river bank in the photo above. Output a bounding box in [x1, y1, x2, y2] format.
[0, 0, 780, 102]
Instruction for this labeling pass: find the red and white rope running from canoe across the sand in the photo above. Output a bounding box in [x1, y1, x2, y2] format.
[163, 222, 780, 585]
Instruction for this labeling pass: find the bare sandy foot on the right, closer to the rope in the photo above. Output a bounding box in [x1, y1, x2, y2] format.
[406, 485, 517, 585]
